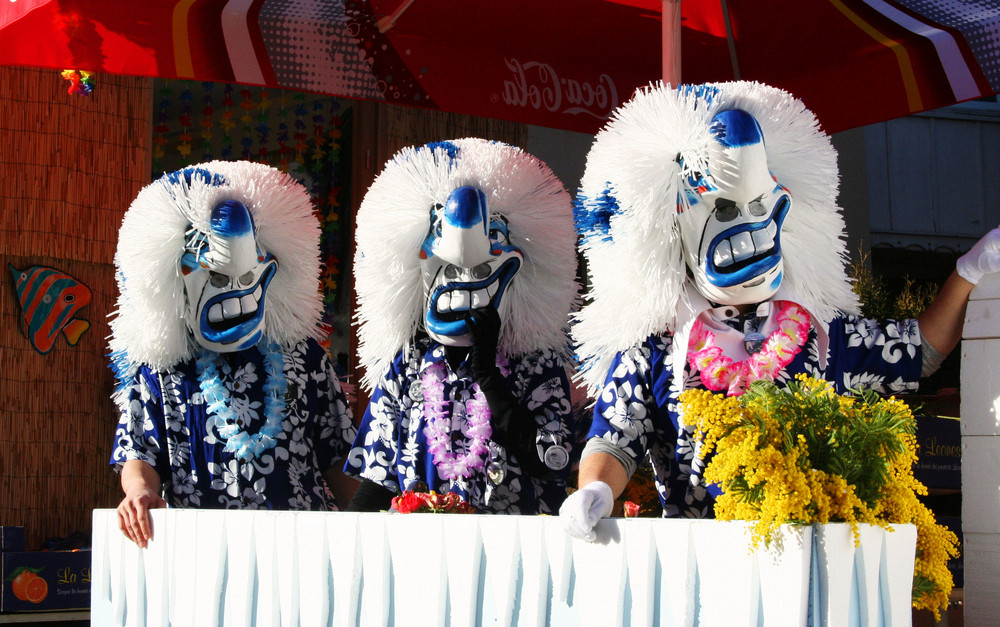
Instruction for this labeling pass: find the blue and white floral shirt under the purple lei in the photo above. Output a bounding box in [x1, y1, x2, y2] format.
[344, 338, 583, 514]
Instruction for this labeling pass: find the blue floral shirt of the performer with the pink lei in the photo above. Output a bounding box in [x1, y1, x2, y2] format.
[588, 316, 922, 518]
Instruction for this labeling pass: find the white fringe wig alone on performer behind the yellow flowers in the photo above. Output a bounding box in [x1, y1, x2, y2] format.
[573, 81, 858, 395]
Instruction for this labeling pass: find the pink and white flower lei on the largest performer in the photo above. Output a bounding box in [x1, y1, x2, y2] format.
[688, 302, 809, 396]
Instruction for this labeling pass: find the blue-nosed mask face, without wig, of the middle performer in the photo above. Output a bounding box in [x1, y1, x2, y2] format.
[420, 185, 524, 346]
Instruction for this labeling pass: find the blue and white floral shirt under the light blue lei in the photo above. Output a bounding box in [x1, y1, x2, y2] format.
[111, 340, 355, 510]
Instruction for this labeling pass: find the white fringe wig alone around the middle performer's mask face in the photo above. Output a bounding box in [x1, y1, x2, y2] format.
[354, 138, 579, 390]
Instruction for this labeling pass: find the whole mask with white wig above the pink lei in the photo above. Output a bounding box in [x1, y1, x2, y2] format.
[572, 81, 858, 395]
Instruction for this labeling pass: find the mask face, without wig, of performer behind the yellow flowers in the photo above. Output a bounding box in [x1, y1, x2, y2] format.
[678, 109, 791, 305]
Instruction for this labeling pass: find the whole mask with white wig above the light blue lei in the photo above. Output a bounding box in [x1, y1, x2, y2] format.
[108, 161, 323, 408]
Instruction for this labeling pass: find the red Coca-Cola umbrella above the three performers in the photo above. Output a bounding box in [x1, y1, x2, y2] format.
[0, 0, 1000, 132]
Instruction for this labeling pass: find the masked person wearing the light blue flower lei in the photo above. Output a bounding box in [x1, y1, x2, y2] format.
[110, 161, 355, 546]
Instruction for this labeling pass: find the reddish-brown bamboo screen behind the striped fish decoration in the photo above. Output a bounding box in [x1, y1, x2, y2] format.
[0, 67, 151, 549]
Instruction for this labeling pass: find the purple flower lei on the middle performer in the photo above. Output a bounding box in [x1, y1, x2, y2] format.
[421, 361, 493, 480]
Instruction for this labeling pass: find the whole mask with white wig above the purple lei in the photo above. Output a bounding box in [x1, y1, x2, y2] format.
[356, 137, 580, 390]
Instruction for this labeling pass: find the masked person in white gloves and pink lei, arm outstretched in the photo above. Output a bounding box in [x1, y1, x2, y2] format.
[560, 82, 1000, 540]
